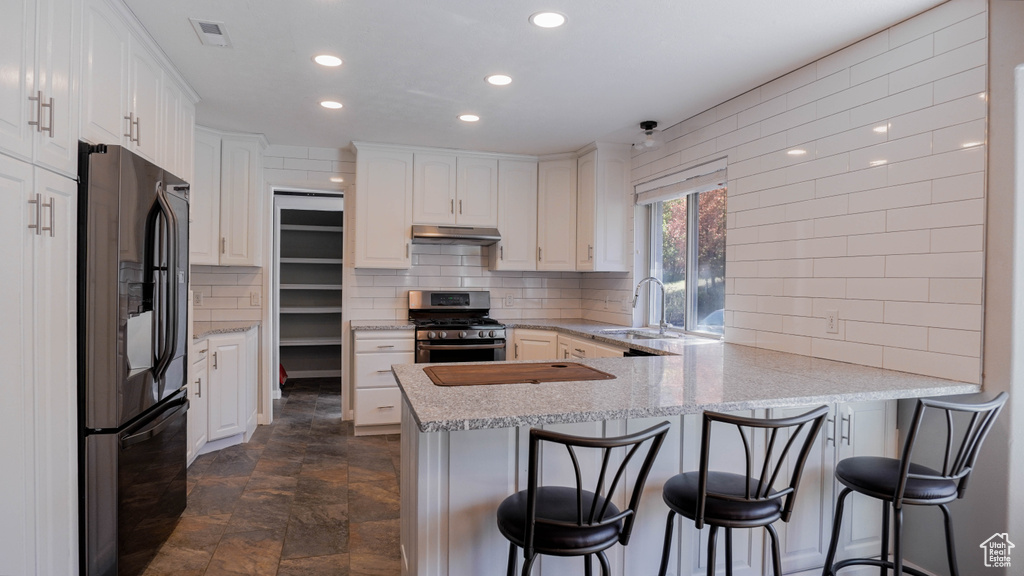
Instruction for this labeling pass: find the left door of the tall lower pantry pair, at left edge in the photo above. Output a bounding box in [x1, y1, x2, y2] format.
[0, 153, 37, 574]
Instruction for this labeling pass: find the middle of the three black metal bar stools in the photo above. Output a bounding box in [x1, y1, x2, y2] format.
[658, 406, 828, 576]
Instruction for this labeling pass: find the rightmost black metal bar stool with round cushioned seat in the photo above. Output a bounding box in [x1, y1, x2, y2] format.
[822, 393, 1009, 576]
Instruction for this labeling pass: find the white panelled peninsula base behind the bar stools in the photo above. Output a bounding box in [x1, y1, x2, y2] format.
[401, 401, 897, 576]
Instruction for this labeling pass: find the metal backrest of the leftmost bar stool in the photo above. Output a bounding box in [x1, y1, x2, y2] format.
[524, 422, 671, 558]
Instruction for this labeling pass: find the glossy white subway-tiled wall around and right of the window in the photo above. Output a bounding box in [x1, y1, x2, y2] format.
[626, 0, 988, 382]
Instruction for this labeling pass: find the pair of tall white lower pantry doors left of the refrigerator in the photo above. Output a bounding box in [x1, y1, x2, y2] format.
[0, 155, 78, 576]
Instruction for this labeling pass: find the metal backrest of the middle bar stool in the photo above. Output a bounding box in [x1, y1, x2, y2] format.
[694, 406, 828, 530]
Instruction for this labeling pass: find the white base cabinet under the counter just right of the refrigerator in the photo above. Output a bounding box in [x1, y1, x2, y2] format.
[188, 327, 259, 462]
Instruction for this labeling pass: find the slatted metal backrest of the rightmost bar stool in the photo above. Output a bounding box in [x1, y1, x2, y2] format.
[894, 392, 1010, 507]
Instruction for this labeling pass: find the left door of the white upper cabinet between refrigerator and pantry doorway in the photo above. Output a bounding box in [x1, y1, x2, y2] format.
[188, 130, 220, 265]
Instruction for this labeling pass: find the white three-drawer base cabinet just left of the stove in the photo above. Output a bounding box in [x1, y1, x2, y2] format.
[352, 330, 416, 436]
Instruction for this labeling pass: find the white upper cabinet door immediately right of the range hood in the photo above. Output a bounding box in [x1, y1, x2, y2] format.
[489, 160, 537, 271]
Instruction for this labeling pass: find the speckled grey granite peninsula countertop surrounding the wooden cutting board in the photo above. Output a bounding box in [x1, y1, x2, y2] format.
[392, 340, 981, 433]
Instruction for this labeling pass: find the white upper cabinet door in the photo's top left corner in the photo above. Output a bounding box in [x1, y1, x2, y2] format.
[0, 0, 38, 160]
